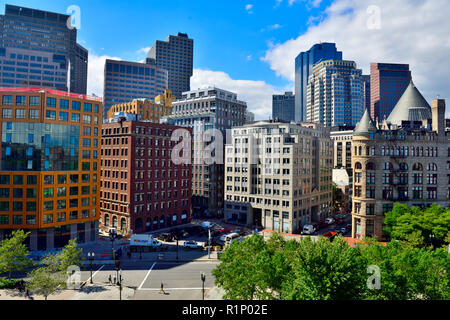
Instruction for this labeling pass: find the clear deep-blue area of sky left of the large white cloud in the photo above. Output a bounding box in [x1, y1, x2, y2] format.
[2, 0, 325, 86]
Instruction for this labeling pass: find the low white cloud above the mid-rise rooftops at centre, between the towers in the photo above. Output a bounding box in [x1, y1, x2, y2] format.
[191, 69, 292, 120]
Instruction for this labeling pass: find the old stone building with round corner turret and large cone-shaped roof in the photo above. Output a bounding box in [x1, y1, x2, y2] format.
[352, 82, 450, 239]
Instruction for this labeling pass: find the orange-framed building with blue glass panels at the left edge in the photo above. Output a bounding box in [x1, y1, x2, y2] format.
[0, 88, 102, 250]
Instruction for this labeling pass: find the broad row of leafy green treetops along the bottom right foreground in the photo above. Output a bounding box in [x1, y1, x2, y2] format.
[213, 233, 450, 300]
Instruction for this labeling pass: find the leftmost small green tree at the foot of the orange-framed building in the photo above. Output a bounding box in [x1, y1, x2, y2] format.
[0, 230, 33, 278]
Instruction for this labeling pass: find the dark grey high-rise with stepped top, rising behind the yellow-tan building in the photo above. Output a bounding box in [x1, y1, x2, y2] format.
[147, 32, 194, 99]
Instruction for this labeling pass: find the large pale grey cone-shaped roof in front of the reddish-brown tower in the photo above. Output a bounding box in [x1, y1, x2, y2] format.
[386, 81, 431, 125]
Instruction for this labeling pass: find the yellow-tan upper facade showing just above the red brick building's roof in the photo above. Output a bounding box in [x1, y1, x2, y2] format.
[108, 90, 175, 123]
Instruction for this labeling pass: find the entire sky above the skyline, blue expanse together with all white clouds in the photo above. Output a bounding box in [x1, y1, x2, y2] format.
[0, 0, 450, 119]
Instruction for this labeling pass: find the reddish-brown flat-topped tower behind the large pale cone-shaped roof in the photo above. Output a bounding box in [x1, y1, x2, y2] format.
[369, 62, 411, 122]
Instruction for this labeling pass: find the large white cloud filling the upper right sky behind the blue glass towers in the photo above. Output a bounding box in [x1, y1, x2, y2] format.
[262, 0, 450, 100]
